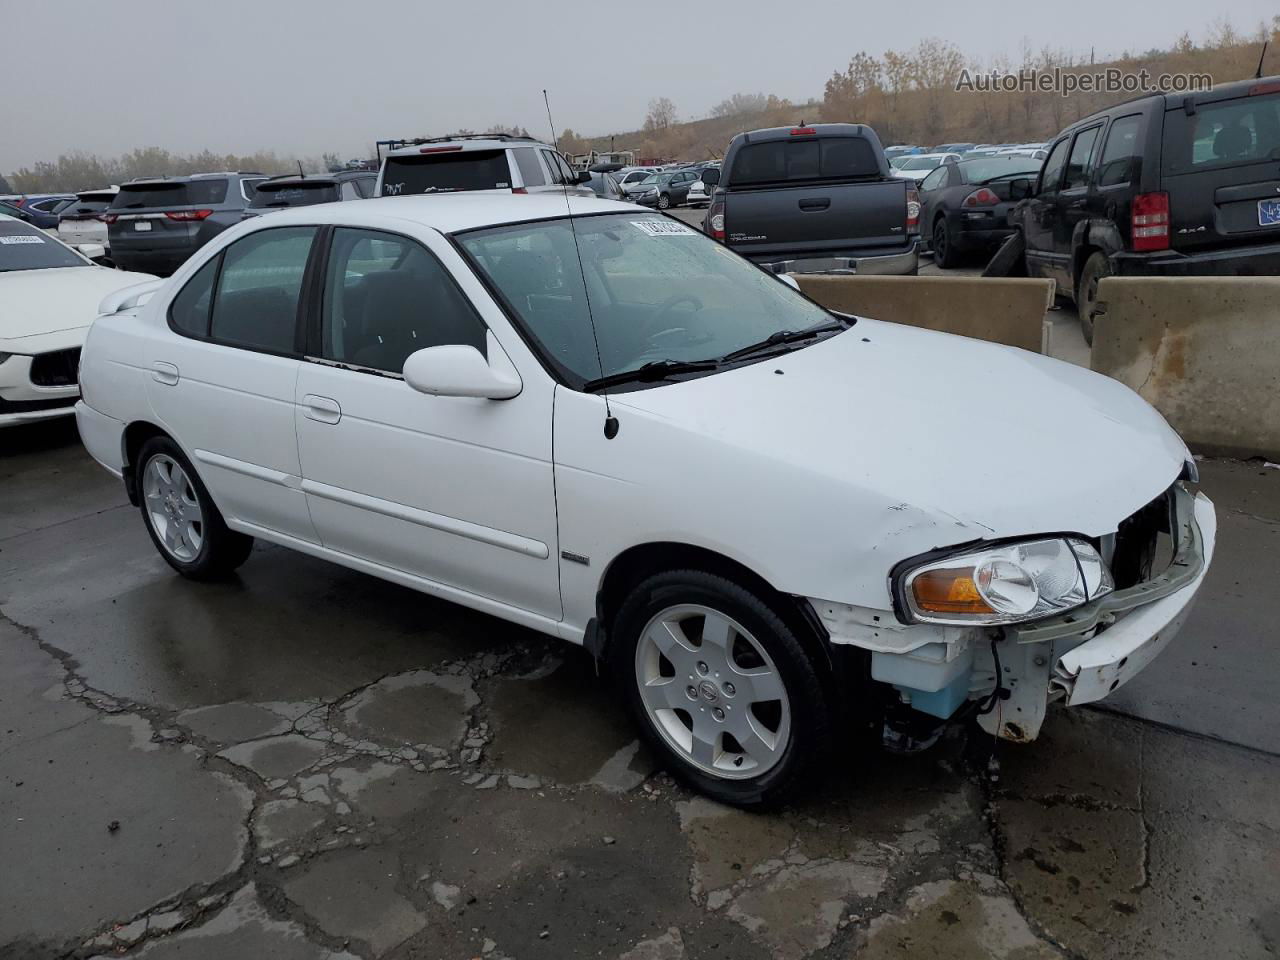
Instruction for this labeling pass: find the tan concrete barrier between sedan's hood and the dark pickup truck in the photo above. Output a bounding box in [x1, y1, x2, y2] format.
[795, 274, 1053, 353]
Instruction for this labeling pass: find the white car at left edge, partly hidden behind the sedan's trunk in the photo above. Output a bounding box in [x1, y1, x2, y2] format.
[0, 215, 155, 428]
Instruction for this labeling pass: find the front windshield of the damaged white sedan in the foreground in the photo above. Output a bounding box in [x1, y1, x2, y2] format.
[458, 212, 832, 385]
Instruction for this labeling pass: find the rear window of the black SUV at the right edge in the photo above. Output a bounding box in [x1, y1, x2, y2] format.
[1161, 93, 1280, 174]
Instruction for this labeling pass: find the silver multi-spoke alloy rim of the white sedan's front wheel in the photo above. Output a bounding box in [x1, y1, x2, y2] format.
[636, 604, 791, 780]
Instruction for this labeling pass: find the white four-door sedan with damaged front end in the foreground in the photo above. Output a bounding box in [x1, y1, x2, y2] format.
[77, 193, 1215, 805]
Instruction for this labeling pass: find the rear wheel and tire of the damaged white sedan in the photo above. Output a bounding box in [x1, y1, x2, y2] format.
[137, 436, 253, 580]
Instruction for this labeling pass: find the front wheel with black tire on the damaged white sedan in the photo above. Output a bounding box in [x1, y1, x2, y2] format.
[609, 570, 831, 806]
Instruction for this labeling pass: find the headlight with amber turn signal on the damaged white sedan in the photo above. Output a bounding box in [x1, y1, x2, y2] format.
[896, 536, 1115, 625]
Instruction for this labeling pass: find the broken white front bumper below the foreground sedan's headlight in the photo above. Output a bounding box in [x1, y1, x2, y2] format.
[978, 486, 1217, 740]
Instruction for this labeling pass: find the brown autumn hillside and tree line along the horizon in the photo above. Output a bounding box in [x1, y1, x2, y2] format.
[8, 15, 1280, 193]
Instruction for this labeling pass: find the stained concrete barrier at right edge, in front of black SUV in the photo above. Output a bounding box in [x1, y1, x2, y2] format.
[1092, 276, 1280, 460]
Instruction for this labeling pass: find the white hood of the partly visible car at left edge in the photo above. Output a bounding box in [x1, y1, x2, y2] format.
[0, 266, 156, 353]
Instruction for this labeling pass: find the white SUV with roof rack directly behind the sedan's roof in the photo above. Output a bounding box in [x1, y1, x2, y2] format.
[375, 133, 595, 197]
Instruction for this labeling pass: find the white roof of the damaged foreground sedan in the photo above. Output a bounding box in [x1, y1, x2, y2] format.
[239, 191, 640, 233]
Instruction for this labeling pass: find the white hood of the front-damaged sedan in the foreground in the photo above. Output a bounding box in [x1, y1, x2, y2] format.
[611, 319, 1189, 542]
